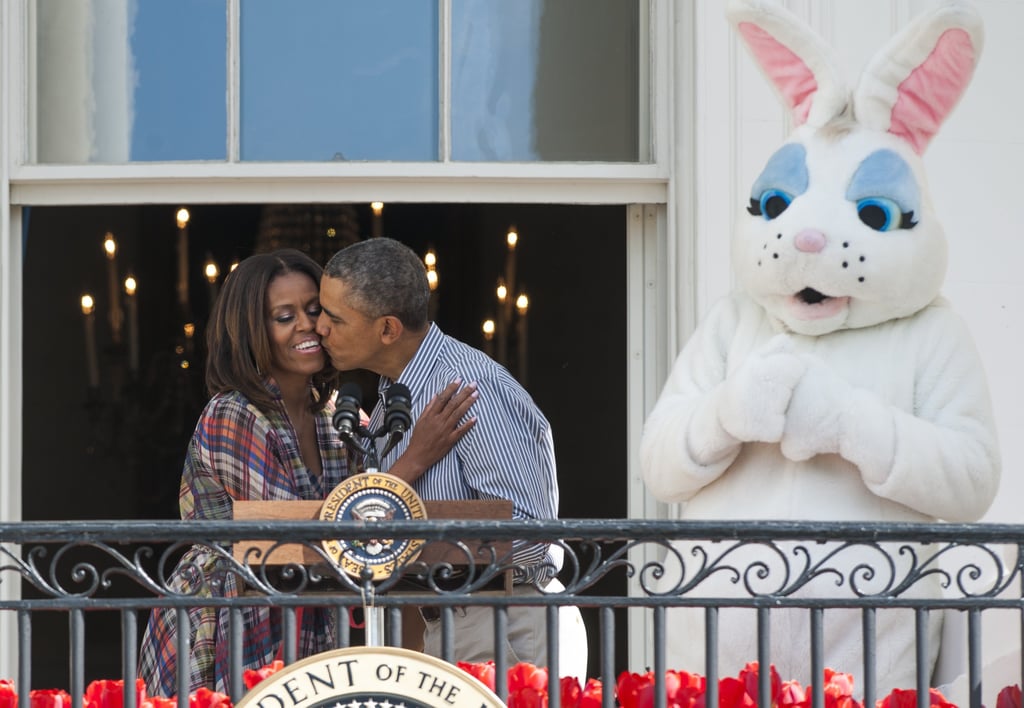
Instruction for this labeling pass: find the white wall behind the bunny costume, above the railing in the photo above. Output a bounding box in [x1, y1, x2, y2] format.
[694, 0, 1024, 523]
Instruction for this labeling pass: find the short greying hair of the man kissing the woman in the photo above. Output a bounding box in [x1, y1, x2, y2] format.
[324, 237, 430, 332]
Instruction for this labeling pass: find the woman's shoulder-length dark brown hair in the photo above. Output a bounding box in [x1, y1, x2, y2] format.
[206, 248, 338, 411]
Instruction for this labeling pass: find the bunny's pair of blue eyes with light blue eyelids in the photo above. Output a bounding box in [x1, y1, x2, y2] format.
[746, 142, 921, 232]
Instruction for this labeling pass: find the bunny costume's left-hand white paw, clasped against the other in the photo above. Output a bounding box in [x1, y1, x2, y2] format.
[718, 334, 807, 443]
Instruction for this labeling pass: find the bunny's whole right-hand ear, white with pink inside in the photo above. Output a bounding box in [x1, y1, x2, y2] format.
[853, 0, 984, 155]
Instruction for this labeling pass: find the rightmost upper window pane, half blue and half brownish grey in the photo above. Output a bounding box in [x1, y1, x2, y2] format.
[452, 0, 640, 162]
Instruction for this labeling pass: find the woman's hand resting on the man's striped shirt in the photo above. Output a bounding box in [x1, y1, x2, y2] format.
[388, 379, 477, 483]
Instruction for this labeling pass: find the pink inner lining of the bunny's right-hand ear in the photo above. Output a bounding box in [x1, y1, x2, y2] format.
[889, 30, 975, 155]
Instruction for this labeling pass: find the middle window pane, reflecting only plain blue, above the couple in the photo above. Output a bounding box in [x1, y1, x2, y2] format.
[241, 0, 438, 161]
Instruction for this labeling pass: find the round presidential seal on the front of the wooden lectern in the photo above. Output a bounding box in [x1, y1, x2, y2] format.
[319, 472, 427, 580]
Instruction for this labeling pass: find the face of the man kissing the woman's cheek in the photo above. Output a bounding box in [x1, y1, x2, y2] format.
[316, 276, 384, 373]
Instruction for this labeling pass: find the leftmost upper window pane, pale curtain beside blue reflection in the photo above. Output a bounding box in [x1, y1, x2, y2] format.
[36, 0, 227, 163]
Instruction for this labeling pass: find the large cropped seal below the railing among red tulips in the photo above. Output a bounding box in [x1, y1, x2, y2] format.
[236, 647, 505, 708]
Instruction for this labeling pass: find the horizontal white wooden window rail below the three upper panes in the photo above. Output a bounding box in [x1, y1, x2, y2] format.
[11, 163, 668, 206]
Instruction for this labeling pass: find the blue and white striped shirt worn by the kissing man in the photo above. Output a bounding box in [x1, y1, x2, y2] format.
[370, 324, 561, 582]
